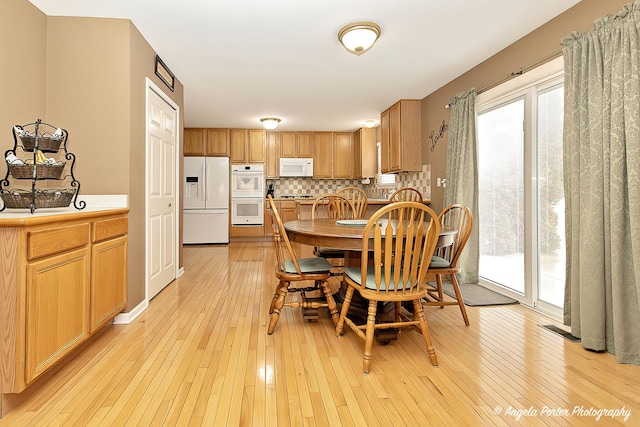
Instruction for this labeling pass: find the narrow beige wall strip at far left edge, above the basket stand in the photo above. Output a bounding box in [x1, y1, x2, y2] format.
[0, 0, 47, 135]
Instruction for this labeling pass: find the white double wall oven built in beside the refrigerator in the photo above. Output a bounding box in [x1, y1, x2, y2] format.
[231, 165, 264, 225]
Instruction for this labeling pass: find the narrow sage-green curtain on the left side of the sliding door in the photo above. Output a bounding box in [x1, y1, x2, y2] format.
[444, 89, 480, 283]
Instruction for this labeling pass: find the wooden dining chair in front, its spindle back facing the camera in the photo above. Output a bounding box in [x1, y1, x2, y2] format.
[336, 202, 440, 373]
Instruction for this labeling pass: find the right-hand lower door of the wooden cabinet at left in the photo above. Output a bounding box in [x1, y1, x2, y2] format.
[89, 236, 127, 333]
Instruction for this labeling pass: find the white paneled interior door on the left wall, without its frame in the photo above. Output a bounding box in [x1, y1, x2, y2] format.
[146, 87, 178, 300]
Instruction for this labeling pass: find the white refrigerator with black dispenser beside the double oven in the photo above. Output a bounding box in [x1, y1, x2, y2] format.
[182, 157, 230, 244]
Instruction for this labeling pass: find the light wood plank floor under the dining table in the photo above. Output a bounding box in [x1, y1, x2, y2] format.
[0, 243, 640, 426]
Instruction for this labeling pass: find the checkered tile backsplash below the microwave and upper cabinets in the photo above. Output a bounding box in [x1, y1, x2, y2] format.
[267, 165, 431, 200]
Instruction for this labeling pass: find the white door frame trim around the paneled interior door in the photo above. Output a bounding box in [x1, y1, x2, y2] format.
[144, 77, 181, 304]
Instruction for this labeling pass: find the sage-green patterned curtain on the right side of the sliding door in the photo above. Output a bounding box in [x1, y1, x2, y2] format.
[562, 0, 640, 364]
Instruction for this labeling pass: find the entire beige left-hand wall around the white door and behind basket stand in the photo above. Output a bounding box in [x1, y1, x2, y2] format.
[0, 0, 184, 311]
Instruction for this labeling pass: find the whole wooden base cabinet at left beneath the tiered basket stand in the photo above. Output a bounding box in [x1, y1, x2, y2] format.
[0, 209, 128, 400]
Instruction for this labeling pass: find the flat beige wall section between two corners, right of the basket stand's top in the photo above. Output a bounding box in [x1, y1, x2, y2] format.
[47, 17, 131, 194]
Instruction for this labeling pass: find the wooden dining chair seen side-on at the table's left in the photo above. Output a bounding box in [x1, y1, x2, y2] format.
[267, 195, 339, 335]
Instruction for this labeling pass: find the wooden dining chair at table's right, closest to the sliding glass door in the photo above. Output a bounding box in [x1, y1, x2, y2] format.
[422, 204, 473, 326]
